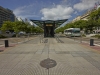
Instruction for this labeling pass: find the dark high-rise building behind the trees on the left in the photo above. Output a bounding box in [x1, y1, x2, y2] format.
[0, 6, 15, 27]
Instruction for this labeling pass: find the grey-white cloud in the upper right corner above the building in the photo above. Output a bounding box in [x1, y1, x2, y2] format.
[73, 0, 100, 11]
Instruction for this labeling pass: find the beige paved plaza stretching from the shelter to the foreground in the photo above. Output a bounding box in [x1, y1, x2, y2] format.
[0, 37, 100, 75]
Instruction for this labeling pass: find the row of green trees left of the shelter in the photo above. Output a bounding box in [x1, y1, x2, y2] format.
[0, 21, 43, 35]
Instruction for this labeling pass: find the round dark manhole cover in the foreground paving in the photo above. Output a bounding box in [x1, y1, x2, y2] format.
[40, 58, 57, 69]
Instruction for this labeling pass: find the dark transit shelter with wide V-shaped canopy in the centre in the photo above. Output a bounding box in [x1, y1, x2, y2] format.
[31, 19, 68, 37]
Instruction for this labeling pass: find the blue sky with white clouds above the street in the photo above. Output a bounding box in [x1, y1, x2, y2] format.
[0, 0, 100, 21]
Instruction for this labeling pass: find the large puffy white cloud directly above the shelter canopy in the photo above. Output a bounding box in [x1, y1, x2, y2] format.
[41, 5, 74, 20]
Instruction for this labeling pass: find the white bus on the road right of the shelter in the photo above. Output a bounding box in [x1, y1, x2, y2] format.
[64, 28, 81, 37]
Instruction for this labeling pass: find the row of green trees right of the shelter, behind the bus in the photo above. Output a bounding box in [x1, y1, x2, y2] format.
[55, 8, 100, 33]
